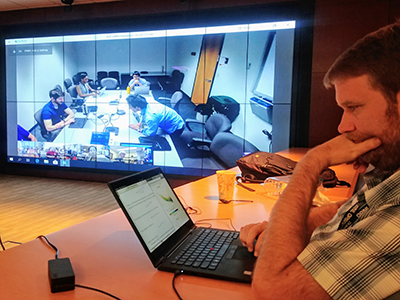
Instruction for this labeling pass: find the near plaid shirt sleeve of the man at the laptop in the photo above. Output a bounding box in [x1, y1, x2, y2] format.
[298, 207, 400, 300]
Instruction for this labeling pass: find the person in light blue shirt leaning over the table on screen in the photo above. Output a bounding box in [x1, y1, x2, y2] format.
[126, 94, 185, 136]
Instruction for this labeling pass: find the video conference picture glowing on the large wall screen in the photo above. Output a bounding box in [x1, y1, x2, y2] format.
[5, 20, 295, 176]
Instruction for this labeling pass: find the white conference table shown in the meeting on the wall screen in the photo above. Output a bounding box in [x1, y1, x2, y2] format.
[54, 90, 182, 167]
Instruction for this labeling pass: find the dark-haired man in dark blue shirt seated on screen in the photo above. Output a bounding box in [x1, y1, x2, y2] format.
[42, 89, 75, 132]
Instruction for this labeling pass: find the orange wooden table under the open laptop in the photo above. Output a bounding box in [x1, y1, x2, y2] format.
[0, 149, 358, 300]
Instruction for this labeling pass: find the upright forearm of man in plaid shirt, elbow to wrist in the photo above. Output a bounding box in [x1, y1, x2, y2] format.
[260, 153, 325, 274]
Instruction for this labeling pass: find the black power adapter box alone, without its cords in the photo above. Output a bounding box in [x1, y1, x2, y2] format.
[48, 258, 75, 293]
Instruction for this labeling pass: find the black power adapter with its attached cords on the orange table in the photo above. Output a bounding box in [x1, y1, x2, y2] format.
[37, 235, 121, 300]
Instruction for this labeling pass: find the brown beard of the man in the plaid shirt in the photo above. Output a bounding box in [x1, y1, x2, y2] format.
[348, 104, 400, 171]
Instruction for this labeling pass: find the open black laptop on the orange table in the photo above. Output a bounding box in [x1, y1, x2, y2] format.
[108, 167, 256, 283]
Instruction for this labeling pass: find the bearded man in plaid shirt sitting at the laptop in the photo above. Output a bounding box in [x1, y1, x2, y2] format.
[240, 22, 400, 300]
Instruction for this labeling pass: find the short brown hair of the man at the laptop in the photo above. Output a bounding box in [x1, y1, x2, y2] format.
[324, 20, 400, 103]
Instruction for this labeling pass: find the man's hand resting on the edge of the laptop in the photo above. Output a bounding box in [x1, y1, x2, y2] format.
[239, 221, 268, 257]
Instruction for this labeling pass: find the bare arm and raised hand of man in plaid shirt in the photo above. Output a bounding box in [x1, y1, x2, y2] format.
[252, 135, 381, 300]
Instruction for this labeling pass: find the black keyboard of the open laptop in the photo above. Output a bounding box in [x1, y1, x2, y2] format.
[171, 228, 239, 270]
